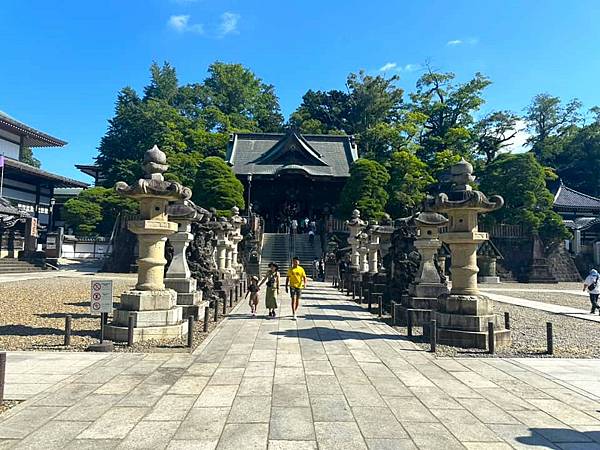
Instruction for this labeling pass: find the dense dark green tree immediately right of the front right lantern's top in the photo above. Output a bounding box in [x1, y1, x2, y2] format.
[480, 153, 569, 245]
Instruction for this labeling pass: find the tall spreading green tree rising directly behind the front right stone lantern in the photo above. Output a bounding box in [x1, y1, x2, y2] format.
[410, 71, 491, 163]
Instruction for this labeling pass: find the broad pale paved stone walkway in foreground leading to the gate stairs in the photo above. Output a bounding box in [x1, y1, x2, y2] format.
[0, 283, 600, 450]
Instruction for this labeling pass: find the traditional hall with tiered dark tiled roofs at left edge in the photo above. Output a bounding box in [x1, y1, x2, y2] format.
[0, 111, 87, 257]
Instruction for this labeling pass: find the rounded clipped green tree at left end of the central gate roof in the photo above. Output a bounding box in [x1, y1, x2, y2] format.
[193, 156, 246, 215]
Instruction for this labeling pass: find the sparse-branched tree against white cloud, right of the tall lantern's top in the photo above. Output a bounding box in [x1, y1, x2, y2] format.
[473, 111, 519, 164]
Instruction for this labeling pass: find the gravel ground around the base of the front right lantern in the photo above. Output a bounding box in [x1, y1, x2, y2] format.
[396, 302, 600, 358]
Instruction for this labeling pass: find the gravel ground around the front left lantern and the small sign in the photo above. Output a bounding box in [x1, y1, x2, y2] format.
[0, 274, 238, 352]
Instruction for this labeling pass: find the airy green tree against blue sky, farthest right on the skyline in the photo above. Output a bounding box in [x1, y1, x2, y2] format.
[525, 94, 581, 164]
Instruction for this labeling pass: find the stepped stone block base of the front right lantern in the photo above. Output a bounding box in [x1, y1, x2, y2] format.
[426, 295, 510, 349]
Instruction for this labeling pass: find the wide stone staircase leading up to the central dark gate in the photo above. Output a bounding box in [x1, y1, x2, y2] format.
[260, 233, 321, 277]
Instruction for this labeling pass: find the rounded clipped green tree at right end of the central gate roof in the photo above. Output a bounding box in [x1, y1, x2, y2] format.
[337, 159, 390, 220]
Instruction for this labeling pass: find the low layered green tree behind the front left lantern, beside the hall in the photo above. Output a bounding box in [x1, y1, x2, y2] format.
[64, 187, 138, 236]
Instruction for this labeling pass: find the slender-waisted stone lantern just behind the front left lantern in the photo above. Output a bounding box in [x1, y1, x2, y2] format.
[165, 200, 210, 317]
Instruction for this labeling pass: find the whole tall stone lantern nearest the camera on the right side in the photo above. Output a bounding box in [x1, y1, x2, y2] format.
[432, 159, 510, 349]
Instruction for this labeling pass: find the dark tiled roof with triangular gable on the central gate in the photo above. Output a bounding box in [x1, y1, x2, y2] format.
[226, 132, 358, 177]
